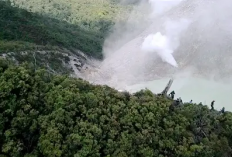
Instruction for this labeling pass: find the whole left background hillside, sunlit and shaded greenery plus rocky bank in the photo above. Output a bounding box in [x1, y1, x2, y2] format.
[0, 0, 133, 77]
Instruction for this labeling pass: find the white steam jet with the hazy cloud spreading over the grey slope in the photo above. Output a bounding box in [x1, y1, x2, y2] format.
[83, 0, 232, 89]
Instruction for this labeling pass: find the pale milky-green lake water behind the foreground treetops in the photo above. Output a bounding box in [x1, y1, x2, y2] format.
[127, 78, 232, 111]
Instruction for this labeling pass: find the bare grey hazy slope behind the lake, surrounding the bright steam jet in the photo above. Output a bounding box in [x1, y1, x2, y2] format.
[84, 0, 232, 87]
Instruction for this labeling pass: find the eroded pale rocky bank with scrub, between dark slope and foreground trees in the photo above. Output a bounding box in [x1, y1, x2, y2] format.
[0, 49, 99, 78]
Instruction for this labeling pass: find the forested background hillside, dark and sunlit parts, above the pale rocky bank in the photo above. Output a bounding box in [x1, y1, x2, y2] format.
[0, 0, 132, 59]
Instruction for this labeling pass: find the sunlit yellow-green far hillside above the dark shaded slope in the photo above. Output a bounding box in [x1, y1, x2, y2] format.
[11, 0, 131, 34]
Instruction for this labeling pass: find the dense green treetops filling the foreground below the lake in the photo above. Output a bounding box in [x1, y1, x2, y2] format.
[0, 57, 232, 157]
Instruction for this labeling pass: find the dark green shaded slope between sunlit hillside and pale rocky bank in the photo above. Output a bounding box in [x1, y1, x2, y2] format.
[0, 1, 103, 57]
